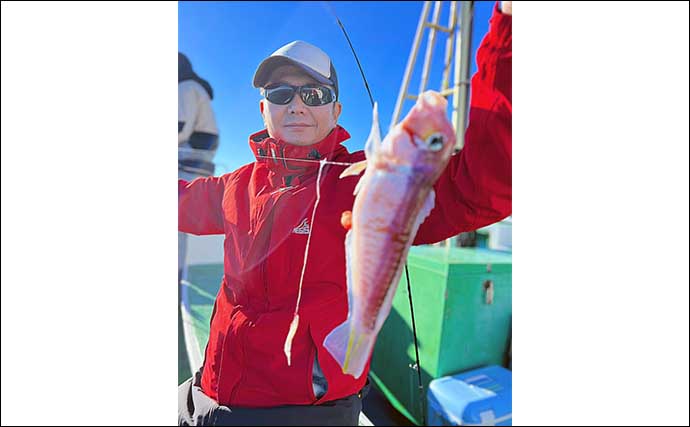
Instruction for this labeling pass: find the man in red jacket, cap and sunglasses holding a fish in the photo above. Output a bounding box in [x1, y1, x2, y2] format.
[179, 2, 512, 425]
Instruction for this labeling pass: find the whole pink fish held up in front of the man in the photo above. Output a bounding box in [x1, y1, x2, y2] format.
[324, 91, 456, 378]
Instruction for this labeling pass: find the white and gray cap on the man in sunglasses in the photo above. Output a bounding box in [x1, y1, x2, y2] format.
[254, 40, 338, 99]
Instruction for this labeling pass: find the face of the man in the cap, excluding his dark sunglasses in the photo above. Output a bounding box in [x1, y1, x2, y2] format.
[260, 65, 342, 145]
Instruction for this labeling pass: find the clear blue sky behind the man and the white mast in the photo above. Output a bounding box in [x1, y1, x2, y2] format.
[178, 1, 494, 174]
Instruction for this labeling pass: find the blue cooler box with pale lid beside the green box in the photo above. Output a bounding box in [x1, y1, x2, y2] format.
[427, 366, 513, 426]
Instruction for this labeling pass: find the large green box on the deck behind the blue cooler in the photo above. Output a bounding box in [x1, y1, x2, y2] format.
[371, 246, 512, 424]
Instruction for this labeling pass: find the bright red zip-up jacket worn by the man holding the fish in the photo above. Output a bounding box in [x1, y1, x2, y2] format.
[179, 5, 512, 407]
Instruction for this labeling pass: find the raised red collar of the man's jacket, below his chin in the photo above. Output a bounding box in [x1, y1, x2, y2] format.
[249, 125, 350, 185]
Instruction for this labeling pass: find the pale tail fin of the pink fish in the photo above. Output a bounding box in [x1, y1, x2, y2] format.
[323, 319, 375, 378]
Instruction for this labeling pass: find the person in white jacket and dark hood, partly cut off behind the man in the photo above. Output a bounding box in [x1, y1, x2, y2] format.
[177, 52, 218, 286]
